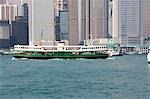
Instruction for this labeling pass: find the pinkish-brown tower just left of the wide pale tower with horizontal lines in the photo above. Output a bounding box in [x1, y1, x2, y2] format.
[90, 0, 108, 39]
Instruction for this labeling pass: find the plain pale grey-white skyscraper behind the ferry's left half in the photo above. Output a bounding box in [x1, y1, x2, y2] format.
[29, 0, 55, 43]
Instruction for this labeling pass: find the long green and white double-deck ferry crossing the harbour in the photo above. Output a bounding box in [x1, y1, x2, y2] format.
[12, 42, 109, 59]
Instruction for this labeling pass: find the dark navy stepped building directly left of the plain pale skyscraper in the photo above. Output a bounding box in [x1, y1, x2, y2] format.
[10, 4, 29, 47]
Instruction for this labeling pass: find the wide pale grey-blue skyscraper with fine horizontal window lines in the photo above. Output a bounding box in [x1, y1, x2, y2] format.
[112, 0, 144, 45]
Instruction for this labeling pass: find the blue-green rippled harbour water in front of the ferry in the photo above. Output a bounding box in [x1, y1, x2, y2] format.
[0, 55, 150, 99]
